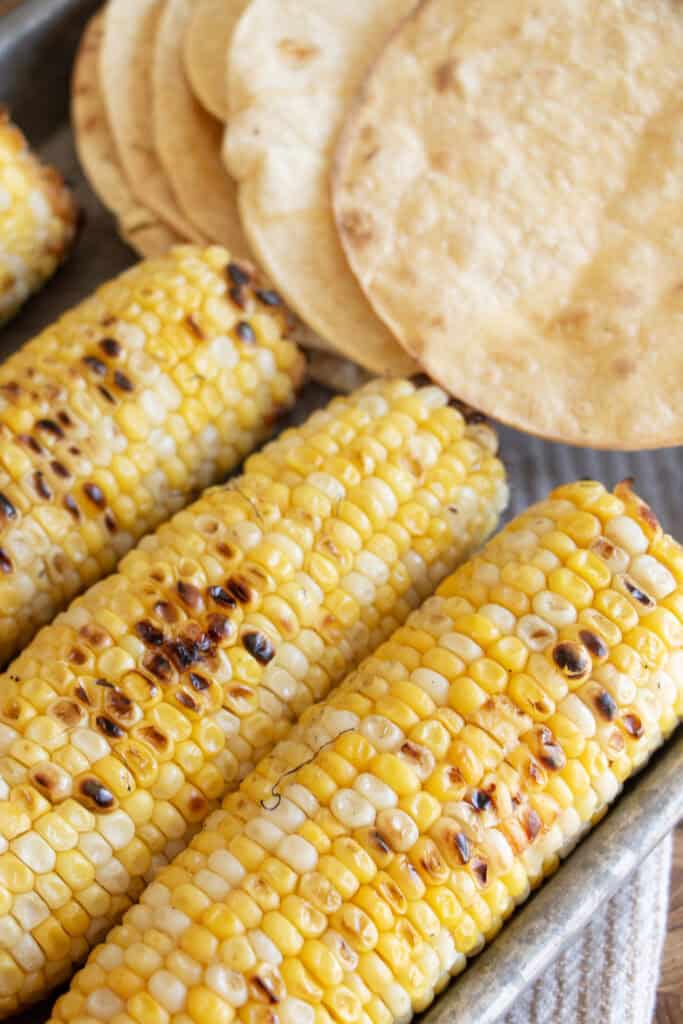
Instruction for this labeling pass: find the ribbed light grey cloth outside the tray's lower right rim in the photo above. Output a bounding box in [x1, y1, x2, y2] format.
[501, 837, 672, 1024]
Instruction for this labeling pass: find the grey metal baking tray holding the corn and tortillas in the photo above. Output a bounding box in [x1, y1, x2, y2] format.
[0, 0, 683, 1024]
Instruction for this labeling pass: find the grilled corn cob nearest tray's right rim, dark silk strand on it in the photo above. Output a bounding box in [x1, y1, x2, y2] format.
[53, 482, 683, 1024]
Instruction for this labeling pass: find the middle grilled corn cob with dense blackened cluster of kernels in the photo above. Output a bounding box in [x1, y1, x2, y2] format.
[0, 381, 506, 1013]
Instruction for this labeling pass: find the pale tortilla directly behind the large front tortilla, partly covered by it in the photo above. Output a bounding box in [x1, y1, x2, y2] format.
[223, 0, 416, 374]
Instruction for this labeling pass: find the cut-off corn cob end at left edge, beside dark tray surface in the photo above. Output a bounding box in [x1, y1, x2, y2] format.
[0, 109, 77, 324]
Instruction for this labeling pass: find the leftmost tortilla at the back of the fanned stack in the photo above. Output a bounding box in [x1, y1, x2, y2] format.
[72, 12, 182, 257]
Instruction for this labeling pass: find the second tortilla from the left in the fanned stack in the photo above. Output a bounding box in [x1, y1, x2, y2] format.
[99, 0, 206, 242]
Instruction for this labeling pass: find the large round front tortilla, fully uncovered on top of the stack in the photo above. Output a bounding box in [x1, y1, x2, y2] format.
[334, 0, 683, 449]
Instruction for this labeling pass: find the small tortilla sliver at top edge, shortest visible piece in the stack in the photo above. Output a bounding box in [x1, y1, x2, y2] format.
[182, 0, 248, 121]
